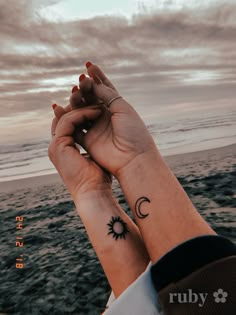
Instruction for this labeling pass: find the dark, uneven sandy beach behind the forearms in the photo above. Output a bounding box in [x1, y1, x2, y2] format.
[0, 144, 236, 315]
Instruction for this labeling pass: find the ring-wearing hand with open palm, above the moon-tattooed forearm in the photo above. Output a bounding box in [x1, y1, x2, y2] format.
[74, 65, 156, 177]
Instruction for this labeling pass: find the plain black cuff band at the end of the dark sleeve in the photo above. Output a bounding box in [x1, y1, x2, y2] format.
[151, 235, 236, 291]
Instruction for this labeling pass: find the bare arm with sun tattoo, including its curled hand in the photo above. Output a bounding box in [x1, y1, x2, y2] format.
[49, 106, 149, 297]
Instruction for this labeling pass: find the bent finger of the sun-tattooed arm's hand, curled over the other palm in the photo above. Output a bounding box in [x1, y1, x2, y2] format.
[56, 106, 101, 137]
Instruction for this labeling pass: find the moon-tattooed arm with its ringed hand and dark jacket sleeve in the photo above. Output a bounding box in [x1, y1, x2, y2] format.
[73, 62, 236, 314]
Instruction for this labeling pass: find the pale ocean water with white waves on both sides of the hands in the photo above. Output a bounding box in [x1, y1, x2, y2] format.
[0, 111, 236, 181]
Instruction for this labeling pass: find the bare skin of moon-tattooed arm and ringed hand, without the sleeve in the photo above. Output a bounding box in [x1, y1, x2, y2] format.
[76, 65, 215, 262]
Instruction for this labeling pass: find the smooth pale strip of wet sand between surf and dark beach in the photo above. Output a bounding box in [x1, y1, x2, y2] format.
[0, 143, 236, 192]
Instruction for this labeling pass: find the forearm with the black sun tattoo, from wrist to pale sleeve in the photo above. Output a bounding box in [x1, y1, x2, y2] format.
[74, 192, 149, 297]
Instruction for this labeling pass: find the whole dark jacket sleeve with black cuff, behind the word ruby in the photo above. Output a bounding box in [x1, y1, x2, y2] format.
[151, 235, 236, 315]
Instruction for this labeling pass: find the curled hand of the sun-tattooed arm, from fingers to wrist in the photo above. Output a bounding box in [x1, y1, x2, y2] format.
[48, 106, 111, 199]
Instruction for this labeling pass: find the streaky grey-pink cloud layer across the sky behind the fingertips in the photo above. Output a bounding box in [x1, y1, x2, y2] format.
[0, 0, 236, 144]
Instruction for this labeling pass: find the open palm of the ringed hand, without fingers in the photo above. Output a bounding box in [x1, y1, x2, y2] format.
[83, 109, 153, 174]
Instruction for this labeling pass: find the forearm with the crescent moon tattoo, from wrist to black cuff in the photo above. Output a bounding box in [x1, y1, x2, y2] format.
[118, 150, 215, 262]
